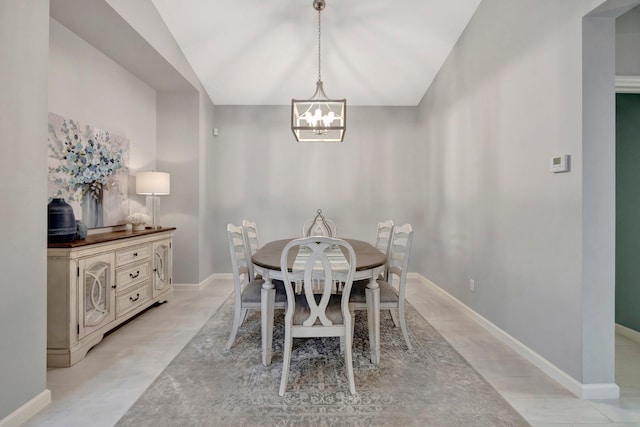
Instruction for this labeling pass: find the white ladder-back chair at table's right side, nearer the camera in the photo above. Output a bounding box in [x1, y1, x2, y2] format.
[350, 224, 413, 350]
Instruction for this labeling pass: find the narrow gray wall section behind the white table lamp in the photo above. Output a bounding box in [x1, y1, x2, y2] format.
[157, 90, 218, 284]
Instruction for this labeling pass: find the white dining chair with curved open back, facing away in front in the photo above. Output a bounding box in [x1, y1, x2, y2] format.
[279, 236, 356, 396]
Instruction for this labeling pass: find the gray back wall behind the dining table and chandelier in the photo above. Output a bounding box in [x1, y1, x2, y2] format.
[206, 104, 427, 272]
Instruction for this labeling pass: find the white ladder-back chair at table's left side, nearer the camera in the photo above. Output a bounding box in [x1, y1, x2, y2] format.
[225, 224, 287, 350]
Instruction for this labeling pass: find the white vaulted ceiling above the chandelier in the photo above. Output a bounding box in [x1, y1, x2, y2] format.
[152, 0, 480, 106]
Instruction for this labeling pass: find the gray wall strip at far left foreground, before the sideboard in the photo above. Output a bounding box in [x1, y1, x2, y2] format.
[0, 0, 49, 420]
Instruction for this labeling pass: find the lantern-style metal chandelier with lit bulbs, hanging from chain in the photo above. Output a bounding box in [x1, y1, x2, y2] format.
[291, 0, 347, 142]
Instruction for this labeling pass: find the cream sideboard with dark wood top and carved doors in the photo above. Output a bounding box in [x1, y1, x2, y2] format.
[47, 228, 175, 367]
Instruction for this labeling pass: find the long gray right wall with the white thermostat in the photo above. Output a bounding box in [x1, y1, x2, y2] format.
[420, 0, 632, 384]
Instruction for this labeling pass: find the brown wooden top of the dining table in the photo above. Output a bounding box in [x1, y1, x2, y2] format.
[251, 238, 386, 271]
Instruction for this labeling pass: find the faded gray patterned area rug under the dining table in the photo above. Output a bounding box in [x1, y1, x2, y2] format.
[117, 299, 529, 427]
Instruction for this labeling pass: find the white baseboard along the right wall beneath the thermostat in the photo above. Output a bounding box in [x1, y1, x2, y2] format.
[407, 273, 620, 399]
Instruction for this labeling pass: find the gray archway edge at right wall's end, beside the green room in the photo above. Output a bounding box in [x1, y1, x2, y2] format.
[581, 0, 640, 399]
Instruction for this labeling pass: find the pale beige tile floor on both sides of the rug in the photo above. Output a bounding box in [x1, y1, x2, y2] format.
[23, 279, 640, 427]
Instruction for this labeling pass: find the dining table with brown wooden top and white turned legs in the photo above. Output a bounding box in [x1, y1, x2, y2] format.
[251, 238, 387, 366]
